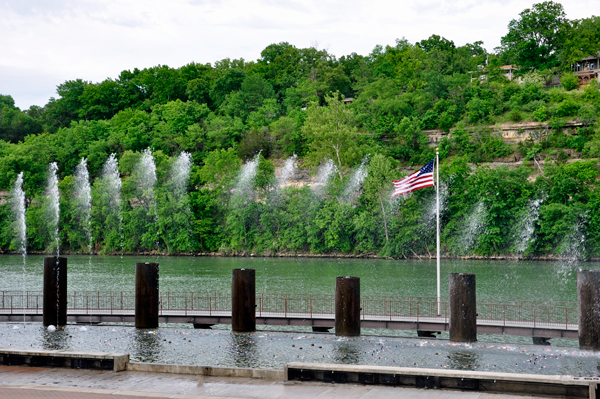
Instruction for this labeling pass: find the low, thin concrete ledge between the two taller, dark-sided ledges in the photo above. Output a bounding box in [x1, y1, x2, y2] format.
[127, 362, 284, 381]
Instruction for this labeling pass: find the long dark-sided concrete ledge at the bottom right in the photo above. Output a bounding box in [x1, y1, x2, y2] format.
[284, 363, 600, 399]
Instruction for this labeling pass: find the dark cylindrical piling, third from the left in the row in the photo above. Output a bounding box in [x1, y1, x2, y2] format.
[231, 269, 256, 332]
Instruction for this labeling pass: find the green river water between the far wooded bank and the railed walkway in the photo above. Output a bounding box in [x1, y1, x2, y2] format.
[0, 255, 600, 302]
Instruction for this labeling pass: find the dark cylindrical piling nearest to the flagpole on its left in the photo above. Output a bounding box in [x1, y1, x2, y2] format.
[335, 277, 360, 336]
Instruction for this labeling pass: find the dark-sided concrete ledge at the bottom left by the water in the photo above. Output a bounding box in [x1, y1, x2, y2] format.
[0, 348, 129, 372]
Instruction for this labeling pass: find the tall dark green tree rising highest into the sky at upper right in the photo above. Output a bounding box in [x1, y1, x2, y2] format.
[501, 1, 567, 69]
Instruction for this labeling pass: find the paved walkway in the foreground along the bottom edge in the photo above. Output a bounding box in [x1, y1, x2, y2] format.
[0, 366, 556, 399]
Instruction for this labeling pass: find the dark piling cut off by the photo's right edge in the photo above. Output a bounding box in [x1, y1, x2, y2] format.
[577, 270, 600, 351]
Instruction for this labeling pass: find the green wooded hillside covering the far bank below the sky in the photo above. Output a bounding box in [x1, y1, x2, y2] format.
[0, 1, 600, 261]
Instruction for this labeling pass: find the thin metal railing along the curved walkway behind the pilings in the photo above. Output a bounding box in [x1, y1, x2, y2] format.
[0, 291, 578, 329]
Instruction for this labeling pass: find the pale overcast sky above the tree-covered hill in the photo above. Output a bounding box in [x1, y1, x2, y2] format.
[0, 0, 600, 109]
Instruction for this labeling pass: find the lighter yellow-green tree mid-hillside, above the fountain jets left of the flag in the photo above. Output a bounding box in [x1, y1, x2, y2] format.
[302, 93, 362, 179]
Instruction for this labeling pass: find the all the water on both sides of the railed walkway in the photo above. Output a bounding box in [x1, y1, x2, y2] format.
[0, 255, 600, 376]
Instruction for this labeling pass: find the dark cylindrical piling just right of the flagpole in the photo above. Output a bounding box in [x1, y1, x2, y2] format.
[448, 273, 477, 342]
